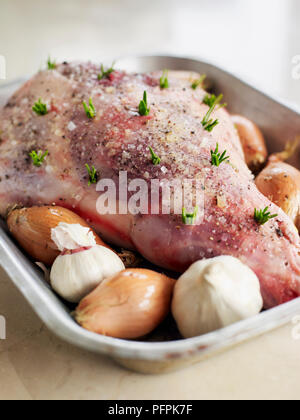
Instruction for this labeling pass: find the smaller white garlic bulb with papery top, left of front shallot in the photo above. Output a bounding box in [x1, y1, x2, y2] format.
[50, 223, 125, 303]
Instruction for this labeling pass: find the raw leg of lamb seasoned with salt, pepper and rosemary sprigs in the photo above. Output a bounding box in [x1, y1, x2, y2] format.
[0, 63, 300, 308]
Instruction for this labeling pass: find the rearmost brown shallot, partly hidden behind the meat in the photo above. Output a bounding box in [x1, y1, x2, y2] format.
[231, 115, 268, 174]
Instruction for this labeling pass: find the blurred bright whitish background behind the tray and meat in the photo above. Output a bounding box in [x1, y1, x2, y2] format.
[0, 0, 300, 105]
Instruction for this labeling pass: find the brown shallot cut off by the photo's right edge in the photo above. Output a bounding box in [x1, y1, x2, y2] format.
[255, 162, 300, 231]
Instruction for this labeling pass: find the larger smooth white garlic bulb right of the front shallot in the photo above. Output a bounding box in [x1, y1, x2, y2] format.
[172, 256, 263, 338]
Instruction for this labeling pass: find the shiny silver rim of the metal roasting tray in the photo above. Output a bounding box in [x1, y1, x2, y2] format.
[0, 54, 300, 362]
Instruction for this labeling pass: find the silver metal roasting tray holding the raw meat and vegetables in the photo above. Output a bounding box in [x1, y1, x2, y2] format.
[0, 56, 300, 373]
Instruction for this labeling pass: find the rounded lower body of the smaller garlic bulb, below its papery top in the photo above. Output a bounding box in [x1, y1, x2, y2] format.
[50, 245, 125, 303]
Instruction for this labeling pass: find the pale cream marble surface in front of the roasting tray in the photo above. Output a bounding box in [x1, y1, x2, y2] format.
[0, 266, 300, 399]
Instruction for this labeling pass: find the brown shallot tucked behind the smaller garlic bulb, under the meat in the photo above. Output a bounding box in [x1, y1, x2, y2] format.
[7, 206, 108, 266]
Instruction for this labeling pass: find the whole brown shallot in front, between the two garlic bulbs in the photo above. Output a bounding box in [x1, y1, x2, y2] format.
[75, 269, 175, 339]
